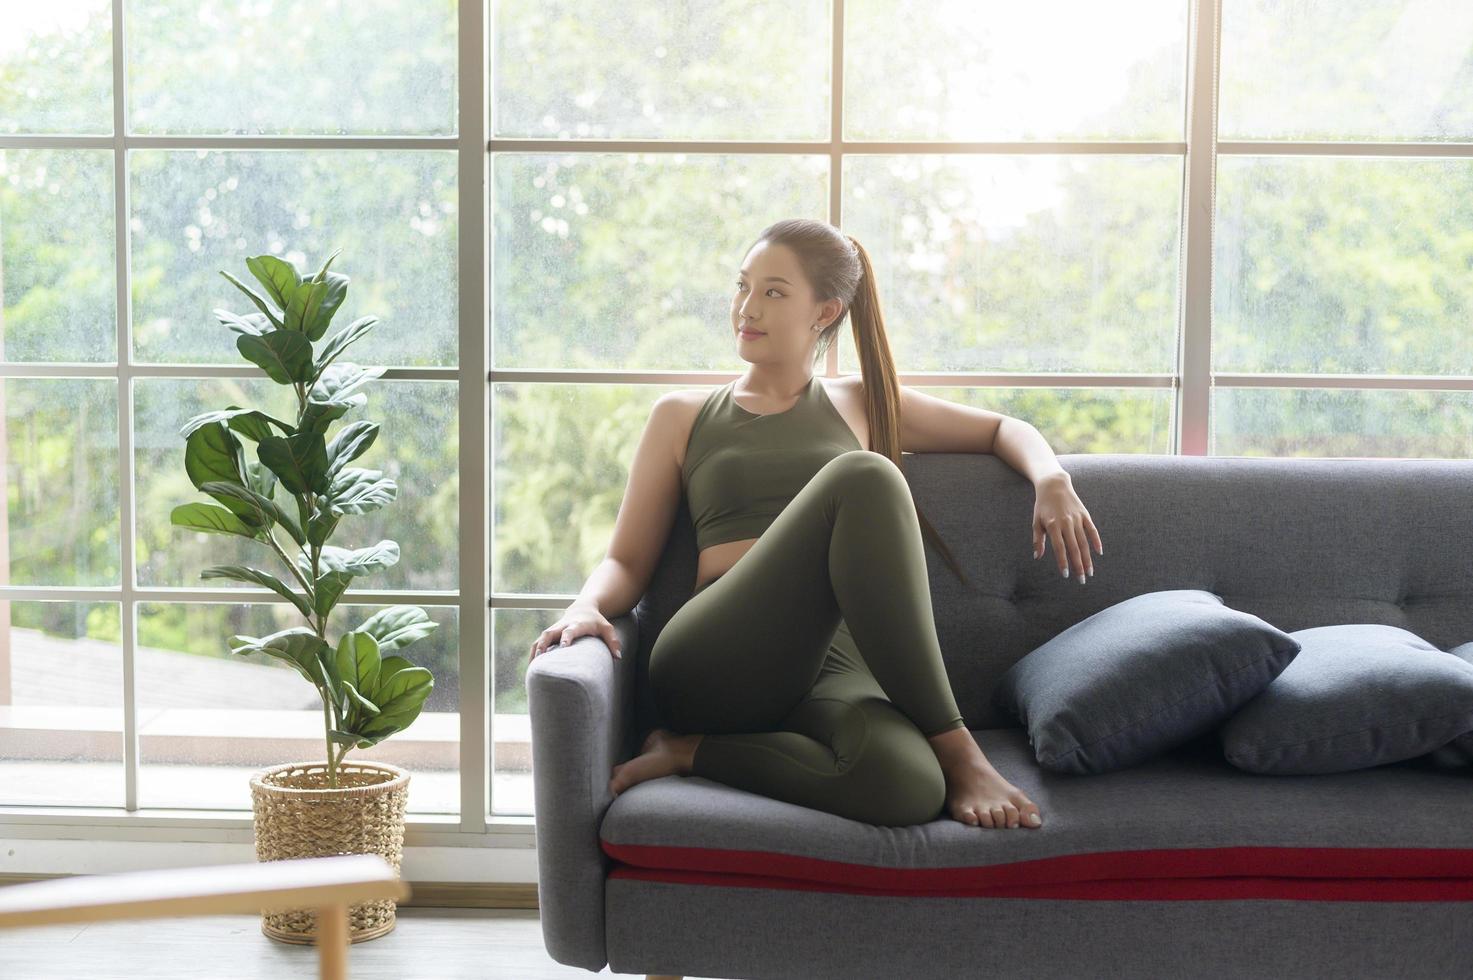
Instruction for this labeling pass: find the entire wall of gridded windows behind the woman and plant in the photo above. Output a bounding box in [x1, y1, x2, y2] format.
[0, 0, 1473, 843]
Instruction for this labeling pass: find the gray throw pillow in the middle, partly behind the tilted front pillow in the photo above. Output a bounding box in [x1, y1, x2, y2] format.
[1218, 623, 1473, 775]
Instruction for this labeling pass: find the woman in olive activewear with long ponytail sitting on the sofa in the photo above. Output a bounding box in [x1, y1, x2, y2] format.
[532, 220, 1103, 828]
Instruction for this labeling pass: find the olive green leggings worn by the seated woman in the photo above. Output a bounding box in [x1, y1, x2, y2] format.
[650, 449, 965, 825]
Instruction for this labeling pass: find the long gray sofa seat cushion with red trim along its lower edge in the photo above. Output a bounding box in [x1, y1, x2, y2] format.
[598, 728, 1473, 900]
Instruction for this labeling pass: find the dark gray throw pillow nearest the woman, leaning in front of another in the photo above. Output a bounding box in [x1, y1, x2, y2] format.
[993, 589, 1299, 775]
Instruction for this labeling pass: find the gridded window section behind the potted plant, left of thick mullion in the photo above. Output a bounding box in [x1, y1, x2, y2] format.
[0, 0, 486, 833]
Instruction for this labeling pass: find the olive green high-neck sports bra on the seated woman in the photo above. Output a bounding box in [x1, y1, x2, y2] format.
[681, 374, 865, 551]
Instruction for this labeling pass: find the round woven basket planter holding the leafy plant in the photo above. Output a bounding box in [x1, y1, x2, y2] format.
[250, 762, 409, 945]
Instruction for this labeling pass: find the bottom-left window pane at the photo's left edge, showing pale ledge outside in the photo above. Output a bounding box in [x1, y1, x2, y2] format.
[0, 600, 124, 806]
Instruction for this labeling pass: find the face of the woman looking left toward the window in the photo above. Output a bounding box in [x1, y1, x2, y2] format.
[732, 242, 844, 363]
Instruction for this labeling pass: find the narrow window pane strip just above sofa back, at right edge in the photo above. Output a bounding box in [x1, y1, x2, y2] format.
[1208, 388, 1473, 460]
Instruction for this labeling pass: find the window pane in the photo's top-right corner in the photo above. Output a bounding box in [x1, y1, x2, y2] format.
[1218, 0, 1473, 140]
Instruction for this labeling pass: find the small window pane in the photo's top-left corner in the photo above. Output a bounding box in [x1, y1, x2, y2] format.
[0, 0, 112, 134]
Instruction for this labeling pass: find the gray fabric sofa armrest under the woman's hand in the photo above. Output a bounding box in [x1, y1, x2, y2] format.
[527, 613, 639, 971]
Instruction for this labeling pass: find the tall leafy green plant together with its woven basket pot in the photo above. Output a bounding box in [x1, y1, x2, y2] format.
[169, 249, 436, 943]
